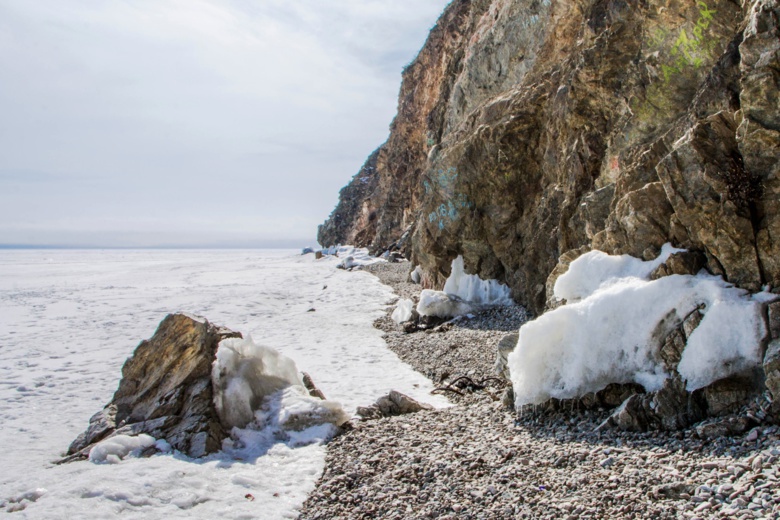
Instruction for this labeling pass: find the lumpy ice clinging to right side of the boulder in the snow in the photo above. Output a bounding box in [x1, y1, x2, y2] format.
[211, 337, 349, 430]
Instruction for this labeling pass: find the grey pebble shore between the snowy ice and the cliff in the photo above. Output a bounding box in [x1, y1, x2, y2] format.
[300, 263, 780, 519]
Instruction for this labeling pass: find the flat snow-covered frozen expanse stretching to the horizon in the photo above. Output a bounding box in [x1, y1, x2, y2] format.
[0, 250, 447, 519]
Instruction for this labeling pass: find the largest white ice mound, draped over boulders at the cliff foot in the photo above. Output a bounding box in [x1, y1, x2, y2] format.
[508, 247, 766, 406]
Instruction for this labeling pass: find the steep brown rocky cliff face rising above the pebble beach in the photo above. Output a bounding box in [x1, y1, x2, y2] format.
[320, 0, 780, 312]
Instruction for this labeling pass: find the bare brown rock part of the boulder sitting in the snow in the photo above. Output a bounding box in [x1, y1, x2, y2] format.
[68, 314, 241, 457]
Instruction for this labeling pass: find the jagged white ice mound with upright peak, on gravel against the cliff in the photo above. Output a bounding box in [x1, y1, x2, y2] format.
[417, 256, 512, 318]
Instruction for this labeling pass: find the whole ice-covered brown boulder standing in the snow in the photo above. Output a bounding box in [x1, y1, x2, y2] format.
[67, 314, 348, 462]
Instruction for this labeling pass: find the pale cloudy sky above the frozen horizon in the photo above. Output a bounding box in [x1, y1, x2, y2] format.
[0, 0, 448, 247]
